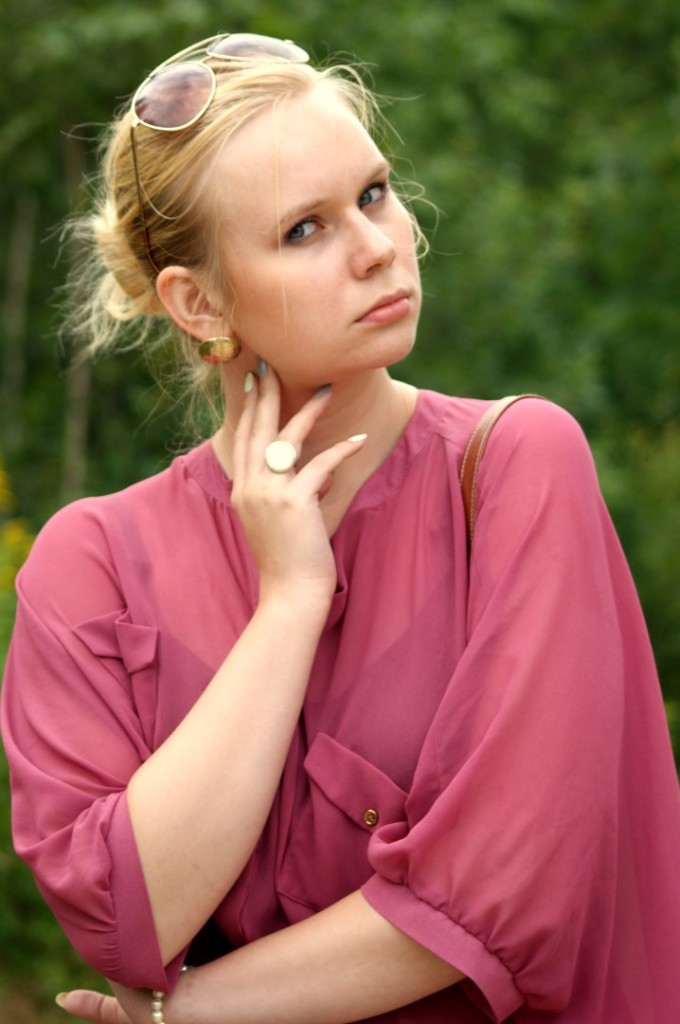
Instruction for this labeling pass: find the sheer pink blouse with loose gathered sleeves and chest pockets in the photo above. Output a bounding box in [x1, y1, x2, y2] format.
[2, 391, 680, 1024]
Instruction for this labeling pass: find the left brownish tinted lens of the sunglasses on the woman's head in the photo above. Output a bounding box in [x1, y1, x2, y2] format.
[133, 63, 215, 129]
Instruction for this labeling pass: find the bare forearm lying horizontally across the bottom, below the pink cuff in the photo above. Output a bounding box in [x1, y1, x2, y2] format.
[167, 893, 462, 1024]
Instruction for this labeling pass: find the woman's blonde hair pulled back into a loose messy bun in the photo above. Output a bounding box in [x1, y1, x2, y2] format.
[65, 48, 420, 421]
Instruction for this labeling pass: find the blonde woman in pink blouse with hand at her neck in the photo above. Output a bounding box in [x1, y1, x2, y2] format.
[3, 36, 680, 1024]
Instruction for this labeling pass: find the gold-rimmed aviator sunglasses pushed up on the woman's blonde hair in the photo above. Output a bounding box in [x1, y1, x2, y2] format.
[130, 32, 309, 273]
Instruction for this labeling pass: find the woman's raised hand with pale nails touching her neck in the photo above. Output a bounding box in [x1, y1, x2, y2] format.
[231, 369, 363, 601]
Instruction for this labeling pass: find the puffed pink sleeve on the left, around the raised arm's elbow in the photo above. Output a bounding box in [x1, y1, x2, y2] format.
[2, 502, 180, 989]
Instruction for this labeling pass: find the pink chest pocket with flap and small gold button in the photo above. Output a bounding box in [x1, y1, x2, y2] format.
[277, 732, 407, 923]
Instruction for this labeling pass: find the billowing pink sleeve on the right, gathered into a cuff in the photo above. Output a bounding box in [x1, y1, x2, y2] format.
[363, 399, 670, 1021]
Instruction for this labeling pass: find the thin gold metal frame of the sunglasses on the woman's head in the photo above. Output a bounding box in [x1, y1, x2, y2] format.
[130, 32, 309, 274]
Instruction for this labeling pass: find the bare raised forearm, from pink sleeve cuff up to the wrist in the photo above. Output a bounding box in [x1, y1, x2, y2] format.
[128, 589, 325, 963]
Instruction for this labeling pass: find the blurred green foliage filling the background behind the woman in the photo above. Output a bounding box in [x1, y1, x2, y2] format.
[0, 0, 680, 1020]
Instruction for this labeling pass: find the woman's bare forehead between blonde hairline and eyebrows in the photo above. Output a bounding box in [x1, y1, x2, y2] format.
[216, 84, 380, 226]
